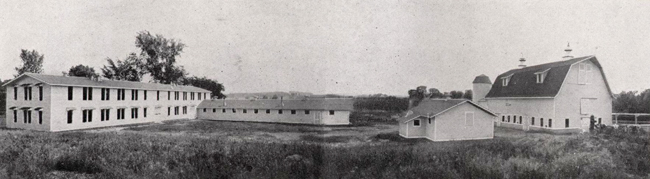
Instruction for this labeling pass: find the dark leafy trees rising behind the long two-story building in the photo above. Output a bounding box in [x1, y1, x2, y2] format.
[14, 31, 226, 98]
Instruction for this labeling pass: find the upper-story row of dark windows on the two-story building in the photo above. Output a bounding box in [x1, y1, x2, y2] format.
[66, 86, 208, 101]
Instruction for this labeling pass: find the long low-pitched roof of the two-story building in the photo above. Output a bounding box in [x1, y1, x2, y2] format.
[2, 73, 210, 92]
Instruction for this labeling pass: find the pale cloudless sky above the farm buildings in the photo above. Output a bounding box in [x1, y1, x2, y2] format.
[0, 0, 650, 96]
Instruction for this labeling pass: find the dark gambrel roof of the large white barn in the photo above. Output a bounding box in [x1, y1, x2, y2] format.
[485, 56, 612, 98]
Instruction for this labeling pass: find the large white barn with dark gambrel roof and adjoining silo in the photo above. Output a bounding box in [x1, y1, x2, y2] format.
[473, 49, 613, 133]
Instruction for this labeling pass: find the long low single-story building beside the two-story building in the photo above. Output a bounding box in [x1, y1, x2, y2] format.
[197, 98, 353, 125]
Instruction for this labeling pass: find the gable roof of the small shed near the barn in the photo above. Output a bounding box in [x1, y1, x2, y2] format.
[397, 99, 497, 122]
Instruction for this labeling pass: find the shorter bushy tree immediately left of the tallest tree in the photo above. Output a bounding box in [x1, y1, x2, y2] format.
[101, 53, 147, 81]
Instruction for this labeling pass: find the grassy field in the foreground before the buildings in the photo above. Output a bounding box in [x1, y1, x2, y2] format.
[0, 120, 650, 178]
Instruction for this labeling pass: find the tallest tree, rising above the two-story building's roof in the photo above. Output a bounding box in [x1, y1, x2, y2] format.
[135, 31, 187, 84]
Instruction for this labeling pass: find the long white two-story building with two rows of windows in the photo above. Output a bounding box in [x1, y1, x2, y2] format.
[3, 73, 211, 131]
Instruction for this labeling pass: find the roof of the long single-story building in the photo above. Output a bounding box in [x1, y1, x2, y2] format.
[198, 98, 354, 111]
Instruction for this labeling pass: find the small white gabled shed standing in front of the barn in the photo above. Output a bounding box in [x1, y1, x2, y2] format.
[398, 99, 497, 141]
